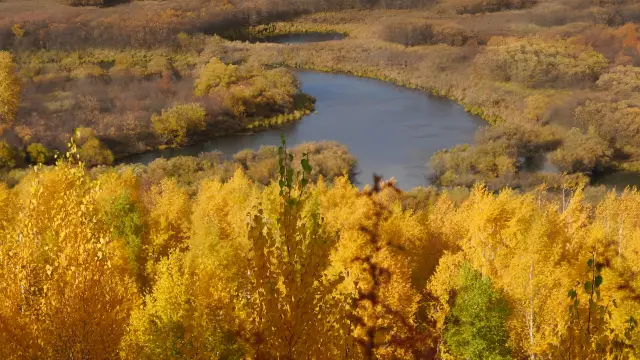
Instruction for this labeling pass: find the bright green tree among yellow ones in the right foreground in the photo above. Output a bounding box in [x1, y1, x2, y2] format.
[444, 264, 511, 360]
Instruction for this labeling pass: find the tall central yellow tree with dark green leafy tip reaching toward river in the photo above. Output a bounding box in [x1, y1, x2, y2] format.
[232, 143, 345, 359]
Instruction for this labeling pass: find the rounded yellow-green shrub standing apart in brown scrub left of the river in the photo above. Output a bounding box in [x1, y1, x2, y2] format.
[151, 103, 207, 146]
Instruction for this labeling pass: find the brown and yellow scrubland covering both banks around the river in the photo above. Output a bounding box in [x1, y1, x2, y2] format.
[0, 0, 640, 189]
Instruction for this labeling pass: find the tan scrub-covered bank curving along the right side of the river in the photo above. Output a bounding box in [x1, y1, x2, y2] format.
[230, 9, 640, 187]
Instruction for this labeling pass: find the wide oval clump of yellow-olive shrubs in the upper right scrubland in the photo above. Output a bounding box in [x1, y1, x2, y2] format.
[474, 37, 607, 87]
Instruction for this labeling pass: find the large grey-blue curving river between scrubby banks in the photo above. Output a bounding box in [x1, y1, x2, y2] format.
[126, 71, 484, 189]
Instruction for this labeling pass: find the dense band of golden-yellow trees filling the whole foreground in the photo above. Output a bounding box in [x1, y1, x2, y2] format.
[0, 148, 640, 359]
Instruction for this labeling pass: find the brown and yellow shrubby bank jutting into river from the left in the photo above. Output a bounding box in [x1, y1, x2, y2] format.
[0, 44, 314, 170]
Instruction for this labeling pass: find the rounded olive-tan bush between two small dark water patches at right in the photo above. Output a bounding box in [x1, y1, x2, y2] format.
[549, 128, 613, 173]
